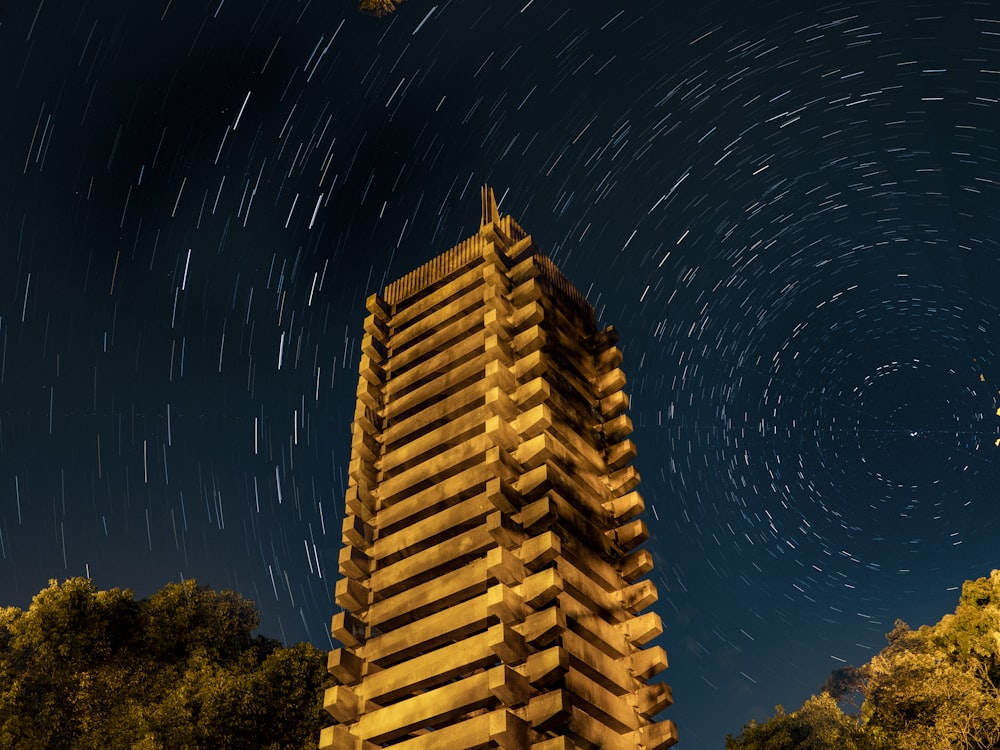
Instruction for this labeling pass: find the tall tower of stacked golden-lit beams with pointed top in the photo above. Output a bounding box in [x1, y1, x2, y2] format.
[320, 187, 677, 750]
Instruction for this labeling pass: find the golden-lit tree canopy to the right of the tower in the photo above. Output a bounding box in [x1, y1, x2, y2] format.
[726, 570, 1000, 750]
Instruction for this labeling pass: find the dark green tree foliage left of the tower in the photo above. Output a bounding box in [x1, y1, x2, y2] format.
[0, 578, 332, 750]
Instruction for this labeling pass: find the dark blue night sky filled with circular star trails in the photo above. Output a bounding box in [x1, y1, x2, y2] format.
[0, 0, 1000, 749]
